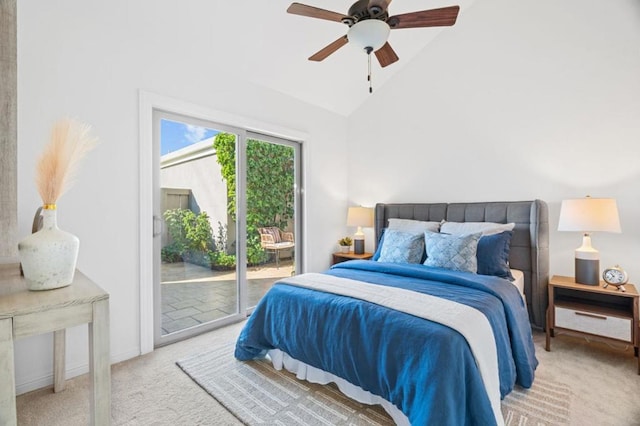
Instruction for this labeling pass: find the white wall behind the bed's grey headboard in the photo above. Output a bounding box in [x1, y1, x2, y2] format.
[349, 0, 640, 283]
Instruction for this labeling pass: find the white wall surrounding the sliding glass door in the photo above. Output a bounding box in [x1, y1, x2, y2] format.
[16, 0, 347, 392]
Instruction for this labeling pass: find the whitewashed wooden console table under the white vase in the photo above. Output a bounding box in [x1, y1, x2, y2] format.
[0, 264, 111, 425]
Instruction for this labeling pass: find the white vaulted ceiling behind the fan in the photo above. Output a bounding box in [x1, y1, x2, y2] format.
[216, 0, 474, 116]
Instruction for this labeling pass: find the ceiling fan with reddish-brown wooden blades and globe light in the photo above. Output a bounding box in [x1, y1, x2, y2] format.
[287, 0, 460, 68]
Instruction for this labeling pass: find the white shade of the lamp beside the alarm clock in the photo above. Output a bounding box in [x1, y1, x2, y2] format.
[558, 197, 621, 232]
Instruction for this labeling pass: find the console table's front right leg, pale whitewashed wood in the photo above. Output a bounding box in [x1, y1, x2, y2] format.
[89, 299, 111, 426]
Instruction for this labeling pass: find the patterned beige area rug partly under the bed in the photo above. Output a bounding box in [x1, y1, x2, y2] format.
[177, 343, 571, 426]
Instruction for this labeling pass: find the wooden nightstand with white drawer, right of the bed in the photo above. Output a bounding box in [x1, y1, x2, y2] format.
[545, 275, 640, 374]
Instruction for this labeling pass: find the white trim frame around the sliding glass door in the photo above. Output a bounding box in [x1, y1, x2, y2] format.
[138, 90, 308, 354]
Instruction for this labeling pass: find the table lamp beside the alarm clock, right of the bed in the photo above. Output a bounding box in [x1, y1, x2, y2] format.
[558, 196, 621, 285]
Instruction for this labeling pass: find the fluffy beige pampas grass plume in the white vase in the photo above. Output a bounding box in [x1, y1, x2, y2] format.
[36, 119, 98, 205]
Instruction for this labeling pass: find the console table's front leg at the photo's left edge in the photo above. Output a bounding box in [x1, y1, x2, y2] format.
[0, 318, 18, 426]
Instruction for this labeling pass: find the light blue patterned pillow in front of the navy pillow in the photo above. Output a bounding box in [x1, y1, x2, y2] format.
[424, 232, 482, 274]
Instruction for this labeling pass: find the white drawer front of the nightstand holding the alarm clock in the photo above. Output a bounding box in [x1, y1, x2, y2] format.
[555, 306, 633, 342]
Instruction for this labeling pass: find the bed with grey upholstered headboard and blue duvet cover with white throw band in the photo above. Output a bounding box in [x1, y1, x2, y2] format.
[235, 200, 548, 425]
